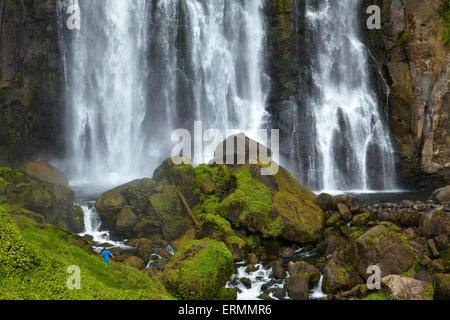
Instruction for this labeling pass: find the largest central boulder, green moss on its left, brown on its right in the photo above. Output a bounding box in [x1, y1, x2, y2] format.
[216, 137, 324, 243]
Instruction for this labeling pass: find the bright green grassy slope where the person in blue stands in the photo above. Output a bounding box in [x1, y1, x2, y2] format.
[0, 206, 173, 300]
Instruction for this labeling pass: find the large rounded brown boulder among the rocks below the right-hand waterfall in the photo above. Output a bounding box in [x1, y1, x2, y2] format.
[345, 225, 421, 279]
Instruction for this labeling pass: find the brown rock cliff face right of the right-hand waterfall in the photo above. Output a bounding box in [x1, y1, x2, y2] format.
[362, 0, 450, 183]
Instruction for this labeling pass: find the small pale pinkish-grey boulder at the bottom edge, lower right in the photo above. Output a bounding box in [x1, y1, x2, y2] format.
[381, 275, 433, 300]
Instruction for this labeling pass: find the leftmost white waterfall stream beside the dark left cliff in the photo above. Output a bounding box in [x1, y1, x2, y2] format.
[59, 0, 148, 184]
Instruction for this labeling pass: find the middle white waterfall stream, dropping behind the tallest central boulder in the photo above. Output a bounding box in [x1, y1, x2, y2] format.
[186, 0, 266, 129]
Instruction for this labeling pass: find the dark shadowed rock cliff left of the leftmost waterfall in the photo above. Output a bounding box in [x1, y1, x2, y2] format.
[0, 0, 64, 168]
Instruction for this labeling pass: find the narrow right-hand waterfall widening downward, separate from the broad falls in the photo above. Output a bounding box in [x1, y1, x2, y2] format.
[306, 0, 396, 192]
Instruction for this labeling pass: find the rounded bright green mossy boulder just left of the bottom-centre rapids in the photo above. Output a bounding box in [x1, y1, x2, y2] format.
[164, 238, 234, 300]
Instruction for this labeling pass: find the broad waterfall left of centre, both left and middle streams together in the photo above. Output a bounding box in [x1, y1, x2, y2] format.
[59, 0, 267, 185]
